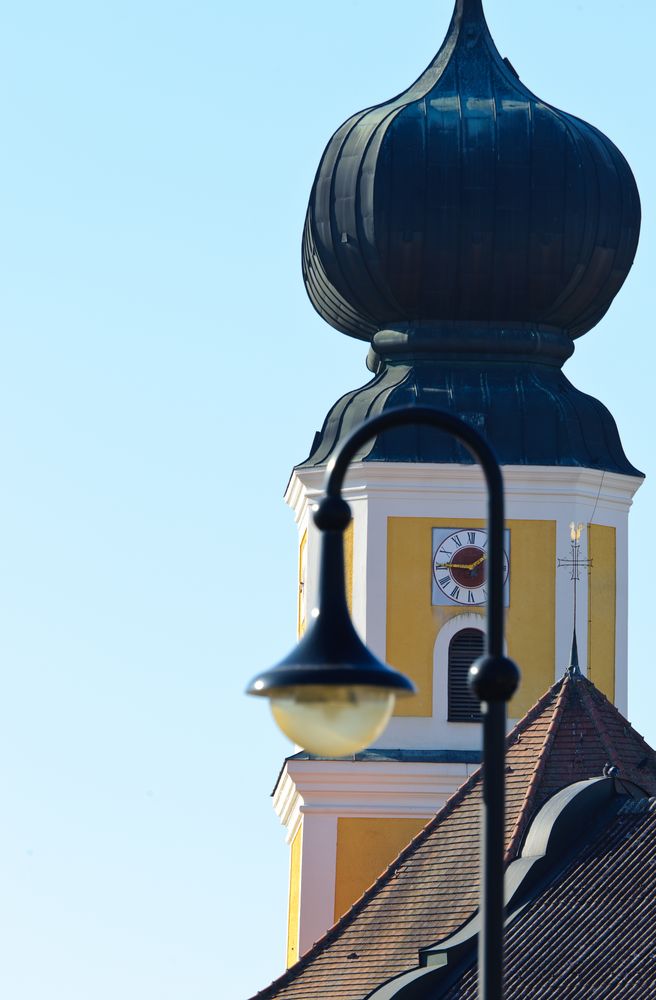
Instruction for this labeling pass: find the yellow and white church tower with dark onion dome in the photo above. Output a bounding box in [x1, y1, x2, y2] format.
[274, 0, 642, 964]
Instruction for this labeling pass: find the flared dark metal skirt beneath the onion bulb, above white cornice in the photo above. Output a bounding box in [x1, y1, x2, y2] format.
[299, 358, 642, 476]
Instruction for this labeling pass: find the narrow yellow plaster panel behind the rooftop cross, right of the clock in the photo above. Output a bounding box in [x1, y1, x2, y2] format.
[588, 524, 617, 702]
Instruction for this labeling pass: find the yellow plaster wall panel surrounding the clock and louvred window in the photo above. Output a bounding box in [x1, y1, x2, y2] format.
[386, 516, 556, 718]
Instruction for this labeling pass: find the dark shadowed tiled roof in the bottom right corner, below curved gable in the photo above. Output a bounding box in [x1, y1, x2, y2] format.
[431, 798, 656, 1000]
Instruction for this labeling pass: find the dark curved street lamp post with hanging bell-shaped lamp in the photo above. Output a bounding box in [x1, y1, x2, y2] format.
[247, 406, 519, 1000]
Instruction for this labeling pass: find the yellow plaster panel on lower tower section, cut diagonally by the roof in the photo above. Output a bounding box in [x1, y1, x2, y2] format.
[335, 816, 427, 920]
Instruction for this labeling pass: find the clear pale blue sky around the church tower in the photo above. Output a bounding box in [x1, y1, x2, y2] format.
[0, 0, 656, 1000]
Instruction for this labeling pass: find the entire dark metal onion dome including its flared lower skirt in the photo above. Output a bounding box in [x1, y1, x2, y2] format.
[302, 0, 641, 476]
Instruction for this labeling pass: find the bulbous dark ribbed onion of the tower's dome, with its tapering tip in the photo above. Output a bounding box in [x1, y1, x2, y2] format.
[303, 0, 640, 350]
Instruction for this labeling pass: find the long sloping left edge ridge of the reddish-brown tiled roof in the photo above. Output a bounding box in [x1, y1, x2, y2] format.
[251, 678, 563, 1000]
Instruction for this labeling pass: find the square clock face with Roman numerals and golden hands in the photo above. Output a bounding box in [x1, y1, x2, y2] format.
[433, 528, 508, 607]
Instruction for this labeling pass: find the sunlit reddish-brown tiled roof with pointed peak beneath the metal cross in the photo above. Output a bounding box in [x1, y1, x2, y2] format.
[252, 675, 656, 1000]
